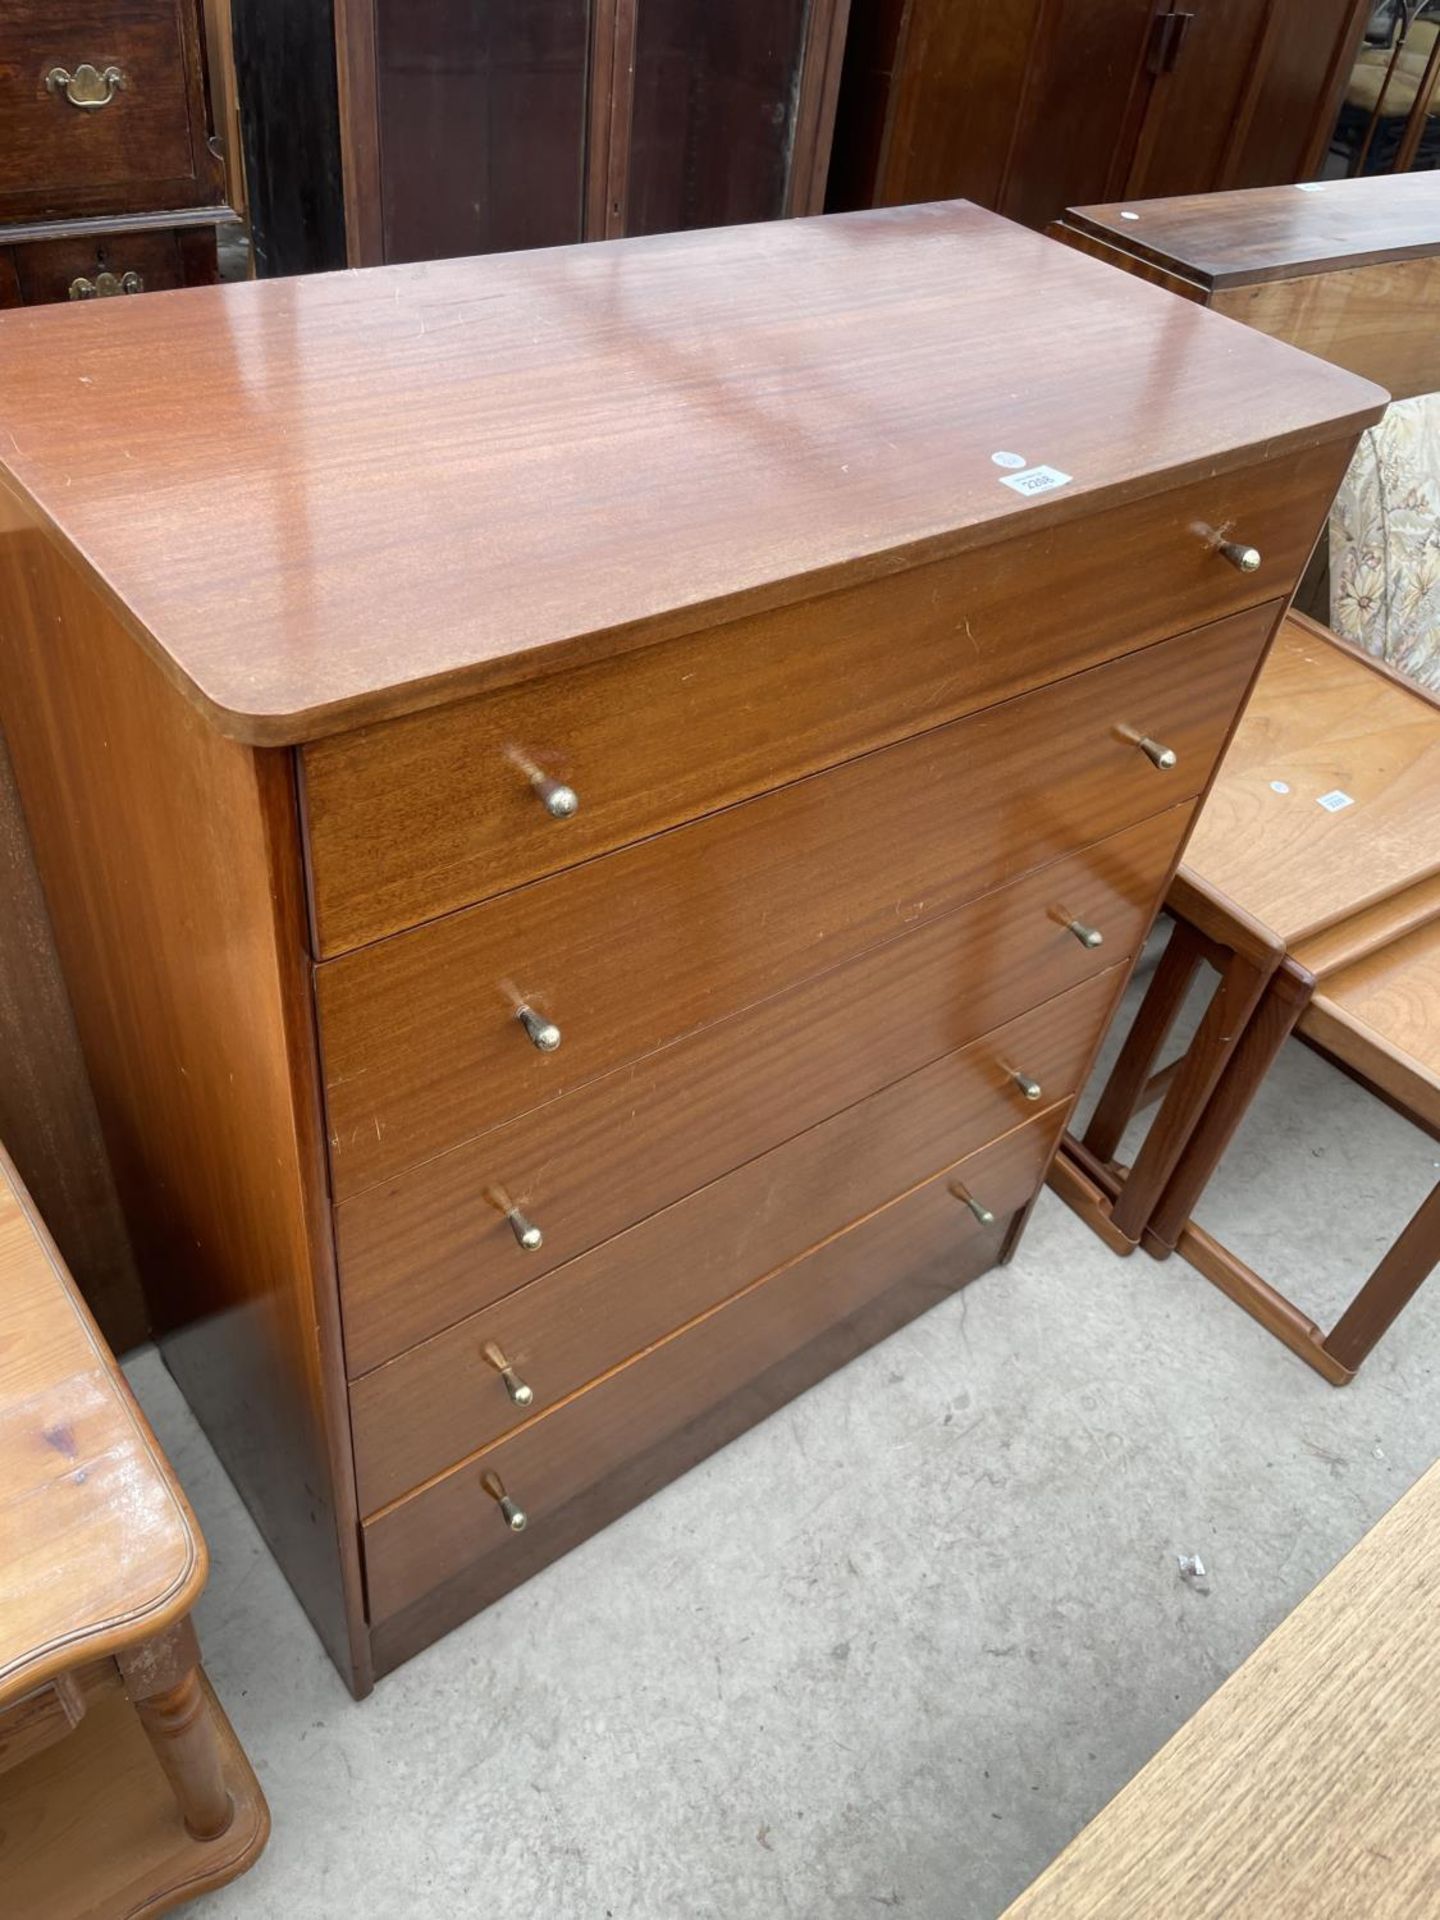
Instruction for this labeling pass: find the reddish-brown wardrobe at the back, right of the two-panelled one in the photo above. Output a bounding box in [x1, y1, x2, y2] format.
[828, 0, 1373, 227]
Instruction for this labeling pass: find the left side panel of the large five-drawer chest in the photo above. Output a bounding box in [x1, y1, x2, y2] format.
[0, 492, 365, 1686]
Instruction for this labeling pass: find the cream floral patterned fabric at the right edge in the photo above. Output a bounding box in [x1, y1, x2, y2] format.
[1331, 394, 1440, 691]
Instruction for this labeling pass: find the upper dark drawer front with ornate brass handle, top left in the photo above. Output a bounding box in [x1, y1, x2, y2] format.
[0, 0, 213, 217]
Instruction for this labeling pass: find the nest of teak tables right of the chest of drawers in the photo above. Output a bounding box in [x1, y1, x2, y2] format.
[1050, 614, 1440, 1386]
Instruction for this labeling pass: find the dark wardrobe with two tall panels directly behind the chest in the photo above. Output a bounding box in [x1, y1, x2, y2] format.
[334, 0, 849, 265]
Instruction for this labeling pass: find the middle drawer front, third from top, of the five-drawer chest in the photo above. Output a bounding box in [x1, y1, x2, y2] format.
[336, 804, 1192, 1375]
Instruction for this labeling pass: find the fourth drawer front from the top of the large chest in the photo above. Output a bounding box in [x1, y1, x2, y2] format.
[351, 968, 1123, 1513]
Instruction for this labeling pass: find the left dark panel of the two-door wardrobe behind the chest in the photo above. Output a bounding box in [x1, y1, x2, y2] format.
[374, 0, 593, 261]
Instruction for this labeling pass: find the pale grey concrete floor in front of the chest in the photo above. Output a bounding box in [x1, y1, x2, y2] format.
[132, 960, 1440, 1920]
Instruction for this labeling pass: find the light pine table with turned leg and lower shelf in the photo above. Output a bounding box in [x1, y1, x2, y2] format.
[0, 1152, 271, 1920]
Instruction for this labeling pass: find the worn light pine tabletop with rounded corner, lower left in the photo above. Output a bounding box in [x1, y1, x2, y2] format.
[0, 1148, 207, 1709]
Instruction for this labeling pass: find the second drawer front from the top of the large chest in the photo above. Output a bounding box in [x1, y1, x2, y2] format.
[317, 607, 1275, 1198]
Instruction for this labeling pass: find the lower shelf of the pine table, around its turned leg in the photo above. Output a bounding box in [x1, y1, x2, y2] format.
[0, 1674, 271, 1920]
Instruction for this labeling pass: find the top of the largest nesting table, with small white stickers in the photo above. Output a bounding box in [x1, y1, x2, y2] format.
[1185, 616, 1440, 947]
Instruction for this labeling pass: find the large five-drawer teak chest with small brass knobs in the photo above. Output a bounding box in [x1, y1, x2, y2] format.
[0, 204, 1382, 1692]
